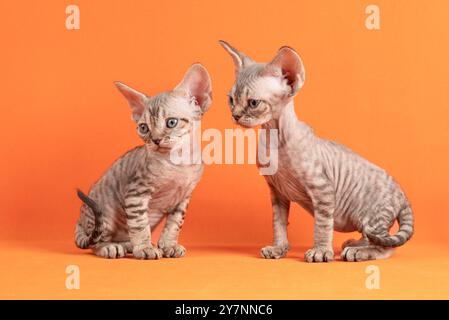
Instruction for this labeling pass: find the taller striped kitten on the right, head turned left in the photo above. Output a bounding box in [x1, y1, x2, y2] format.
[220, 41, 413, 262]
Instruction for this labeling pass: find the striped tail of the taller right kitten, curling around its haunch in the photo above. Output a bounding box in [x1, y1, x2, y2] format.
[365, 206, 414, 247]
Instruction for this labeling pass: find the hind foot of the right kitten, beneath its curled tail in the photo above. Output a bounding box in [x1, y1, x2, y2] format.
[341, 238, 394, 262]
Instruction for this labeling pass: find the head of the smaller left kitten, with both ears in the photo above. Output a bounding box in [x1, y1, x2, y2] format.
[115, 64, 212, 153]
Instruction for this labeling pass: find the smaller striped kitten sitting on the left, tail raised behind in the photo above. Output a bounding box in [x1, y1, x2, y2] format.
[75, 64, 212, 259]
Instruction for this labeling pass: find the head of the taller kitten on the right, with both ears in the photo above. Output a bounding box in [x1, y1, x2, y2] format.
[220, 41, 305, 127]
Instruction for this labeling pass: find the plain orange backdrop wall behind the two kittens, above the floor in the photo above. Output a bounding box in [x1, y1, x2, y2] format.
[0, 0, 449, 300]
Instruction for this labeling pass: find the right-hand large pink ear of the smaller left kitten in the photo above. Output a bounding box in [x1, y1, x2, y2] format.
[174, 63, 212, 113]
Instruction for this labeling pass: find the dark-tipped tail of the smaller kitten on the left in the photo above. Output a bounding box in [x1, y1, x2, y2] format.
[76, 189, 103, 249]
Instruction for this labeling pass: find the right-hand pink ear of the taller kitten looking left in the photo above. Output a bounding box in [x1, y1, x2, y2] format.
[267, 47, 306, 96]
